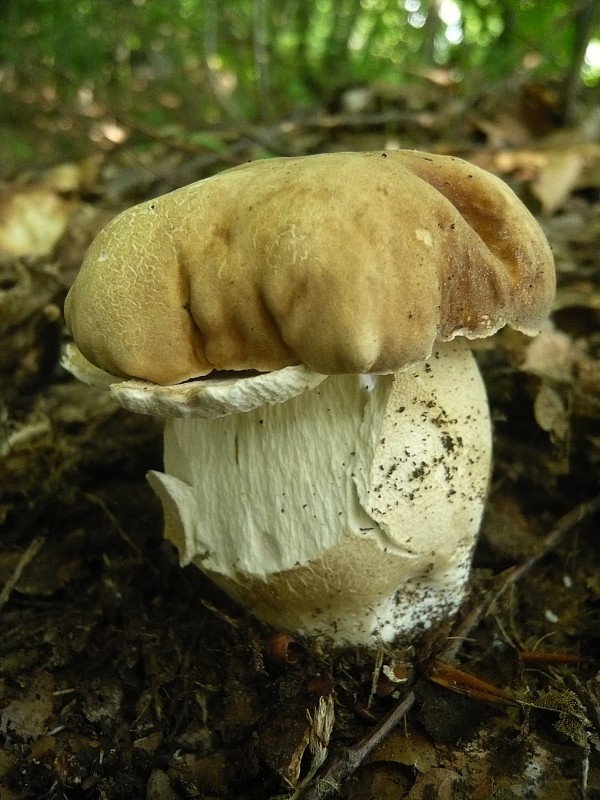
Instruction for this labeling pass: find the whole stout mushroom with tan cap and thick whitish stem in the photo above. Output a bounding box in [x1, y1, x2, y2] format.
[64, 151, 554, 645]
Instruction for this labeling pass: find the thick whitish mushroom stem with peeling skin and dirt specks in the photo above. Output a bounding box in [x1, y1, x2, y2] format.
[149, 342, 491, 644]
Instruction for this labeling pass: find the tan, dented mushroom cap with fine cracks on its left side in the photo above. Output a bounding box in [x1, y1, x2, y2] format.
[65, 151, 555, 384]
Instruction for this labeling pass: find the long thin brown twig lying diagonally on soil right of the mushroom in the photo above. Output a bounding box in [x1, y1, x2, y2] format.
[292, 495, 600, 800]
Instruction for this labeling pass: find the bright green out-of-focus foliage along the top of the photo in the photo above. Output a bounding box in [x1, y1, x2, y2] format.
[0, 0, 600, 124]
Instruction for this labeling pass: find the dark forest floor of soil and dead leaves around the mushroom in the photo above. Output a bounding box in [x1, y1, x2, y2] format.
[0, 83, 600, 800]
